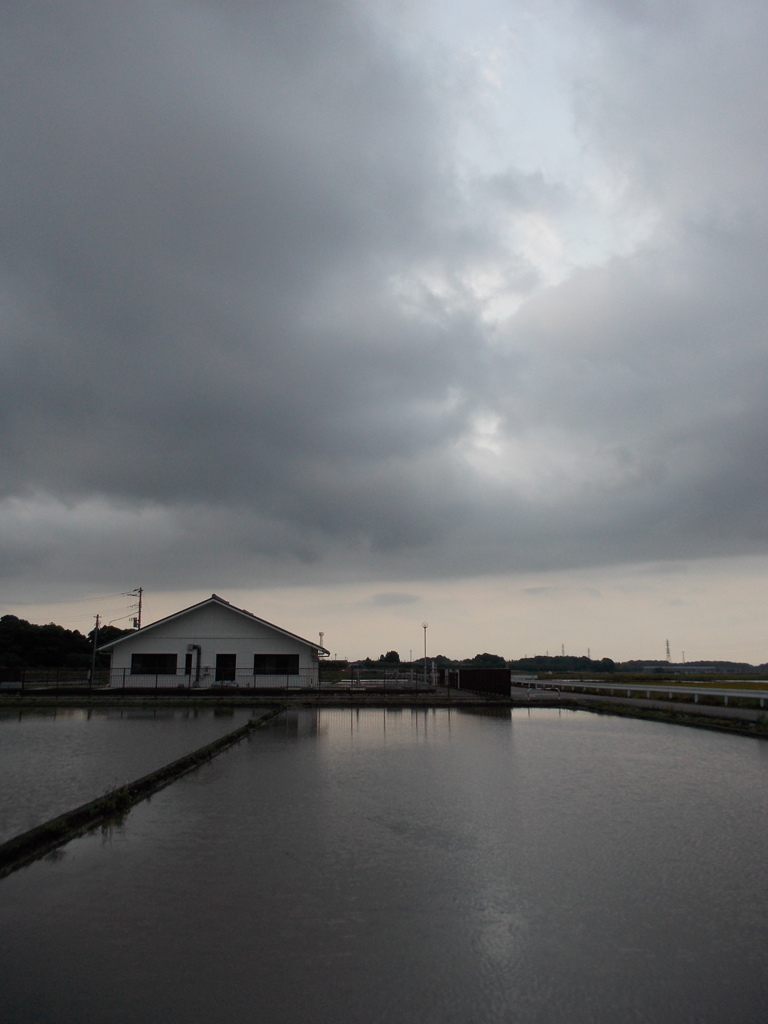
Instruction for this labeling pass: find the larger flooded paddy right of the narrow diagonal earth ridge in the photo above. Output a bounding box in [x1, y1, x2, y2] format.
[0, 709, 768, 1024]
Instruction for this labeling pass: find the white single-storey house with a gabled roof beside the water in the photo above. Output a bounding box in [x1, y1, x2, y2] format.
[99, 594, 329, 687]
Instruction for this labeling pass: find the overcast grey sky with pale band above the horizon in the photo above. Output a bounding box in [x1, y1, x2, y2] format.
[0, 0, 768, 662]
